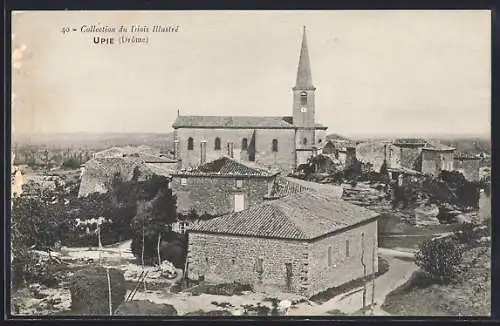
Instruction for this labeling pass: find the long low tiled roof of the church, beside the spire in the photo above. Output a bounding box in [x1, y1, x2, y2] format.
[172, 115, 327, 129]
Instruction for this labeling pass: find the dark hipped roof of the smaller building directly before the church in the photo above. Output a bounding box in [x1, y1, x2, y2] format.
[175, 156, 276, 176]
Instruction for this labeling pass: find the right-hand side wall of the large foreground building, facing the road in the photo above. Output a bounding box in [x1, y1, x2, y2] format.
[307, 221, 378, 295]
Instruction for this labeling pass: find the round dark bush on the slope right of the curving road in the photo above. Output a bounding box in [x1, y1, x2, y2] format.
[415, 238, 463, 282]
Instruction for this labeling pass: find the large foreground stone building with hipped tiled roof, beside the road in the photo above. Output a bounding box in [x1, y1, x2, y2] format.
[187, 191, 378, 296]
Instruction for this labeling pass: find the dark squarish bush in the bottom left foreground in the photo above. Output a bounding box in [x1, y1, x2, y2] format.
[70, 267, 127, 315]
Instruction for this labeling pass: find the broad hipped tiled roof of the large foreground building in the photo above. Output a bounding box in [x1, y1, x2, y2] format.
[191, 191, 378, 240]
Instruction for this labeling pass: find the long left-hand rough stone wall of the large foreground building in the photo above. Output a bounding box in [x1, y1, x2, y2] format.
[188, 232, 308, 292]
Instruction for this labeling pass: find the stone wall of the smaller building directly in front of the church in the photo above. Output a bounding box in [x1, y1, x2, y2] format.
[171, 176, 272, 215]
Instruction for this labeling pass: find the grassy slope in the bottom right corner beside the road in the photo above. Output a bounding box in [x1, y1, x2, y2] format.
[382, 247, 491, 316]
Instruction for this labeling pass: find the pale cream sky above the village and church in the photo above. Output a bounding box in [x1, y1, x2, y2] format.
[12, 10, 491, 136]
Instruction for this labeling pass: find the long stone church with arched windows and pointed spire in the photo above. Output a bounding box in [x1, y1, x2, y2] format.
[172, 27, 327, 172]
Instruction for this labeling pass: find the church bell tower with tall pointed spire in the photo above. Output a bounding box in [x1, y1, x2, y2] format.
[292, 26, 316, 155]
